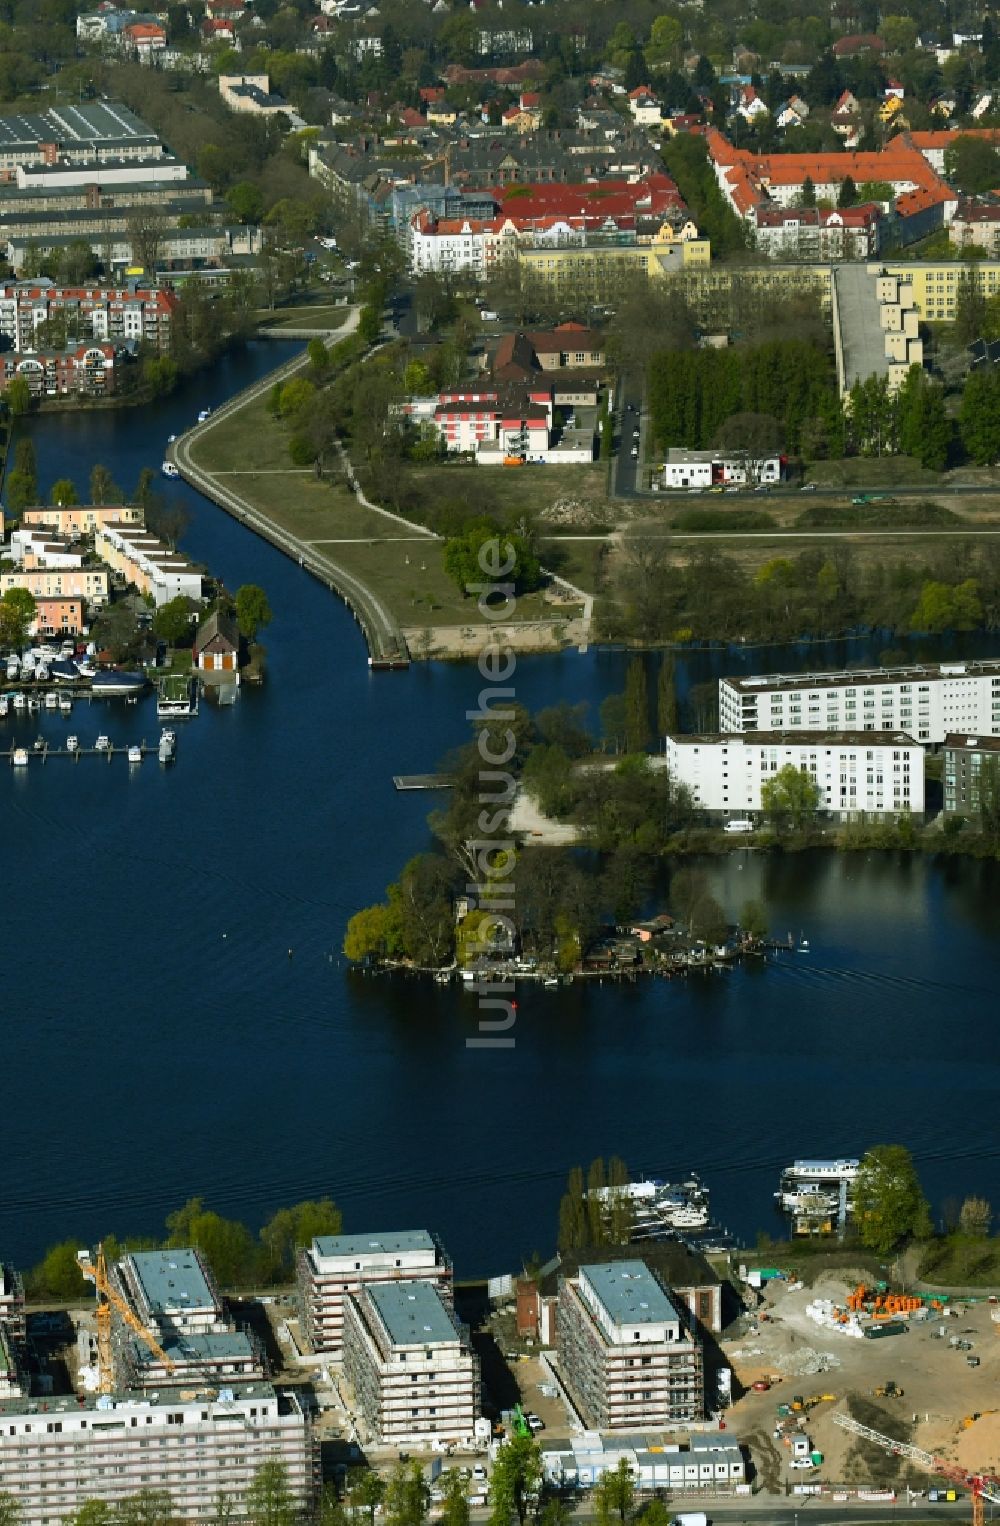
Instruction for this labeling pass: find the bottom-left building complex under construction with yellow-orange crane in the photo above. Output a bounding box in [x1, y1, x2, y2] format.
[0, 1247, 318, 1526]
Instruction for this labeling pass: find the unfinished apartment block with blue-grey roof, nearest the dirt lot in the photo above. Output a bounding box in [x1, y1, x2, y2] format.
[556, 1260, 705, 1431]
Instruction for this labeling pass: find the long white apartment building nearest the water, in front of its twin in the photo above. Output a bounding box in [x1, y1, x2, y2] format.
[666, 731, 924, 821]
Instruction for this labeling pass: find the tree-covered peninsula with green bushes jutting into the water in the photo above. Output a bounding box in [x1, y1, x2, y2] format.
[344, 658, 1000, 983]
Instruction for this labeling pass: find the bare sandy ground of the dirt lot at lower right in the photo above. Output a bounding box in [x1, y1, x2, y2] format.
[724, 1273, 1000, 1488]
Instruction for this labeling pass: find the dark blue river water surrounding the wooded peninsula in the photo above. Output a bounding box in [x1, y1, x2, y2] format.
[0, 345, 1000, 1274]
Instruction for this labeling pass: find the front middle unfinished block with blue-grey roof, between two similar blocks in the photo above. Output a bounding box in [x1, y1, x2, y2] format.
[344, 1282, 479, 1447]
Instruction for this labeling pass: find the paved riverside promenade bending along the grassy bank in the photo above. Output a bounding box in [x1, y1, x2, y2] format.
[166, 307, 409, 668]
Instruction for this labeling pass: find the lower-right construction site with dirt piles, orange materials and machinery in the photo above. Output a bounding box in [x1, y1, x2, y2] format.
[721, 1273, 1000, 1505]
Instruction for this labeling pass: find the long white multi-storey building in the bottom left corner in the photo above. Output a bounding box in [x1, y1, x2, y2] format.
[0, 1383, 315, 1526]
